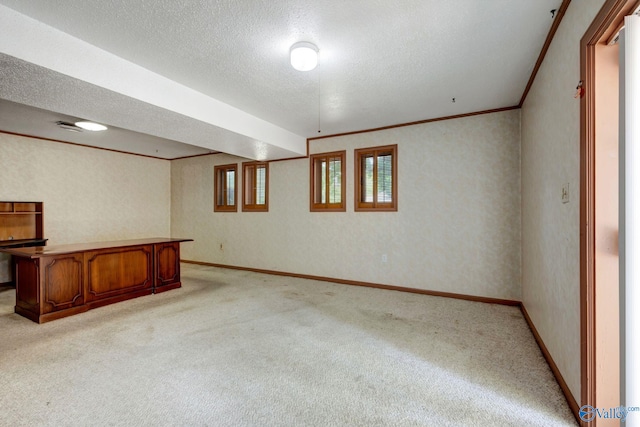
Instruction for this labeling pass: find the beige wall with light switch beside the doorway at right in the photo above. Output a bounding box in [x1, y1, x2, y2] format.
[522, 0, 604, 402]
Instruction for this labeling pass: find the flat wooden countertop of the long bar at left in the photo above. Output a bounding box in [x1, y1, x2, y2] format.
[0, 237, 193, 259]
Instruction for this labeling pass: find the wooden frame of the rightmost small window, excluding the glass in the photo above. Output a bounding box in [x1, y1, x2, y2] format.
[353, 144, 398, 212]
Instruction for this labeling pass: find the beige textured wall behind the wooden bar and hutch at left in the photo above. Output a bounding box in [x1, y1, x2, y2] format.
[0, 133, 171, 283]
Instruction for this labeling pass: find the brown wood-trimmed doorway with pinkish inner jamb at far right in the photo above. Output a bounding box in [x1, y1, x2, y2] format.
[580, 0, 640, 425]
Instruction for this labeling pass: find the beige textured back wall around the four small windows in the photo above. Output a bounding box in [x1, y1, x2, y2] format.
[171, 110, 521, 300]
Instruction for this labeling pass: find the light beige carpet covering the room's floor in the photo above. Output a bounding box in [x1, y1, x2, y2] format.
[0, 264, 576, 426]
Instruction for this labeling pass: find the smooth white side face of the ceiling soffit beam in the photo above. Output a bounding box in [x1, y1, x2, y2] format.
[0, 5, 306, 159]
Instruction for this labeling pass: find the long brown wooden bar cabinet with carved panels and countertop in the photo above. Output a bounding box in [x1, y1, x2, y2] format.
[0, 238, 191, 323]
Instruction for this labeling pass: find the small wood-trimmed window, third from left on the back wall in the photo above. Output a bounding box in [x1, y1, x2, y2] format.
[309, 151, 346, 212]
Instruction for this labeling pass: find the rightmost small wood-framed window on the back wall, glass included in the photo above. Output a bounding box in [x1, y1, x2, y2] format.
[354, 145, 398, 211]
